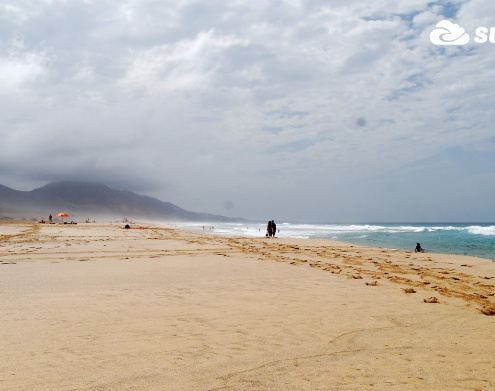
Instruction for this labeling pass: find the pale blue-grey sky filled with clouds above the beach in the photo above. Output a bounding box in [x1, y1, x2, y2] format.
[0, 0, 495, 222]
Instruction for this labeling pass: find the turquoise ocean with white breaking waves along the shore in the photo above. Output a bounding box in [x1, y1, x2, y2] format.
[179, 222, 495, 260]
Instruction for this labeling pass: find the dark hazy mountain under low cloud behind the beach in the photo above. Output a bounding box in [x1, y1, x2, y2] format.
[0, 181, 242, 222]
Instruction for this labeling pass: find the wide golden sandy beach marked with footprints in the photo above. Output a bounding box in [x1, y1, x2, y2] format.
[0, 223, 495, 391]
